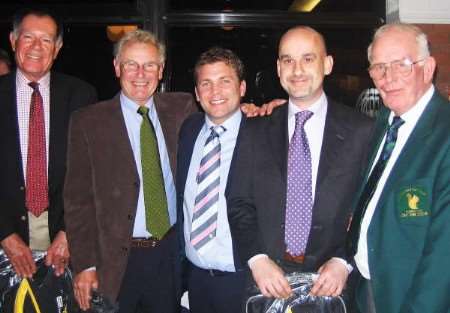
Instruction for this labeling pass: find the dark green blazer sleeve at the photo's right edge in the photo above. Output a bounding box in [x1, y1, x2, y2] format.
[402, 147, 450, 313]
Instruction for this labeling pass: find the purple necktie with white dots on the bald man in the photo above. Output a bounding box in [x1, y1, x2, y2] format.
[284, 111, 313, 256]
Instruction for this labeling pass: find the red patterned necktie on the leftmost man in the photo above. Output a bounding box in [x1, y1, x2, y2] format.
[25, 82, 48, 216]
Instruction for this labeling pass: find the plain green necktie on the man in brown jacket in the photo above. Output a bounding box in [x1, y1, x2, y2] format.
[138, 106, 170, 239]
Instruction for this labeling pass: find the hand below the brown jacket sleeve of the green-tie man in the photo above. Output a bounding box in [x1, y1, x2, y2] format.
[73, 270, 98, 311]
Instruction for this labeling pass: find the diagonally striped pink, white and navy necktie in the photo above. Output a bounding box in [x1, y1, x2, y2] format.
[191, 126, 225, 251]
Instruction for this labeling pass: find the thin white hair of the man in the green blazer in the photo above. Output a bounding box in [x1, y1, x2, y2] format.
[367, 23, 430, 62]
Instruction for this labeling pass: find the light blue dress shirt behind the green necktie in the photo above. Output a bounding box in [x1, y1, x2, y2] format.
[120, 93, 176, 237]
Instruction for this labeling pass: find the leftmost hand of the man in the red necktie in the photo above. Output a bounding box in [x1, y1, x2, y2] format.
[1, 233, 36, 278]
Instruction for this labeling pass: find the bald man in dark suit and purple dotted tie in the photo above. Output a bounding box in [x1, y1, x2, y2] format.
[228, 26, 372, 298]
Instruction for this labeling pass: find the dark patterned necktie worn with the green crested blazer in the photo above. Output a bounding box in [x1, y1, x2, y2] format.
[347, 116, 405, 256]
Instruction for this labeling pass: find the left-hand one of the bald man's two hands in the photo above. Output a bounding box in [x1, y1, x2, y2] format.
[250, 257, 292, 298]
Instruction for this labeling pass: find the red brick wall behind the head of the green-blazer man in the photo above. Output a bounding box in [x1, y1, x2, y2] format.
[417, 24, 450, 99]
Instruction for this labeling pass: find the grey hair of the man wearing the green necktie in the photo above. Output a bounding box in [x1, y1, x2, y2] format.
[114, 29, 166, 63]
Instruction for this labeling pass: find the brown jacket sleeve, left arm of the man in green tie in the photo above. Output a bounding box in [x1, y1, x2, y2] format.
[64, 112, 97, 273]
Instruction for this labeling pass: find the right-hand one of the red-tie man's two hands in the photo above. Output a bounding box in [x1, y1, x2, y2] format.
[45, 231, 70, 276]
